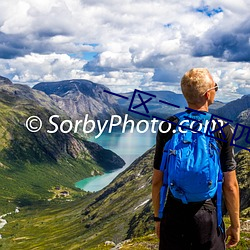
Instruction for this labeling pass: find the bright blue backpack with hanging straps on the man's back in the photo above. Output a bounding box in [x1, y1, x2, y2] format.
[159, 111, 223, 227]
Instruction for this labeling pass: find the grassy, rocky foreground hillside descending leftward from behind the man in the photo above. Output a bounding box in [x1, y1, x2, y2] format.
[0, 147, 250, 250]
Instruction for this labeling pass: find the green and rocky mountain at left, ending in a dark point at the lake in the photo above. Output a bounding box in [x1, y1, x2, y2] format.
[0, 79, 125, 212]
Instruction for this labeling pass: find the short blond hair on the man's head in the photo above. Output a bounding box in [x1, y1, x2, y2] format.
[181, 68, 213, 104]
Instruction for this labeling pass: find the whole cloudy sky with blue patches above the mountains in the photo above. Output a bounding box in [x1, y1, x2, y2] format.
[0, 0, 250, 102]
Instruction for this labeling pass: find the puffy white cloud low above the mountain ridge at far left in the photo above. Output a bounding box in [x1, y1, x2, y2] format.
[0, 53, 86, 85]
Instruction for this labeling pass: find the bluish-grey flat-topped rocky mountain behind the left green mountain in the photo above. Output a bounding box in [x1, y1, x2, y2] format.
[33, 79, 123, 121]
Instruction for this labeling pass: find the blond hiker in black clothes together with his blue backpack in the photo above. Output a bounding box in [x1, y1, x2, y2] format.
[152, 68, 240, 250]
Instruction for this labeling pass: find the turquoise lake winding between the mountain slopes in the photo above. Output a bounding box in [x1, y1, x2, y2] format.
[75, 130, 156, 192]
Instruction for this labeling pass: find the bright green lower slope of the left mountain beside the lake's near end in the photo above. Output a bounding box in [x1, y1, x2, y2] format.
[0, 156, 100, 214]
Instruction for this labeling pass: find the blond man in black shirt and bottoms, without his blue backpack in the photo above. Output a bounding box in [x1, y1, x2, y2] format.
[152, 68, 240, 250]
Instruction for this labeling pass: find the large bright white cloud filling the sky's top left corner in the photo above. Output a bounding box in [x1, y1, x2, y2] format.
[0, 0, 72, 35]
